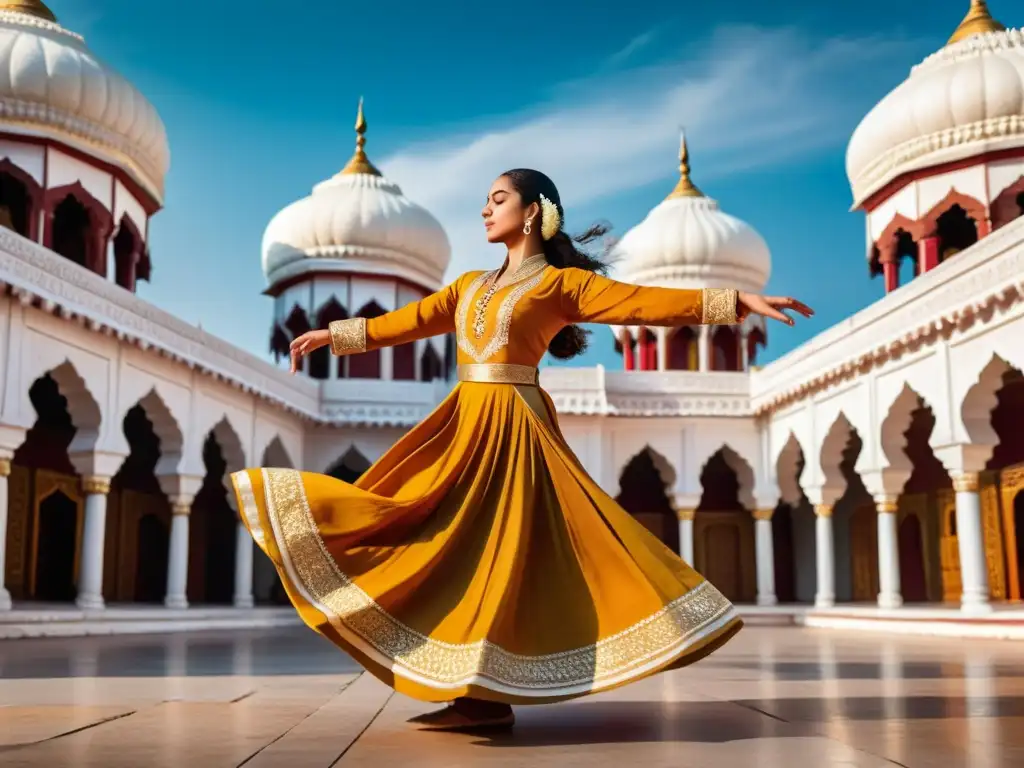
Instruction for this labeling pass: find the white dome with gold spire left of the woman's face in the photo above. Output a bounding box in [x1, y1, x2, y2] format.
[263, 103, 452, 290]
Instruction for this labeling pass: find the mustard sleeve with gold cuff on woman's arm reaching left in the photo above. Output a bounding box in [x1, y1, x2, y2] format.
[328, 278, 462, 354]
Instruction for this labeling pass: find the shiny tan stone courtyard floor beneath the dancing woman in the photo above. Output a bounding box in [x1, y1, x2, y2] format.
[0, 627, 1024, 768]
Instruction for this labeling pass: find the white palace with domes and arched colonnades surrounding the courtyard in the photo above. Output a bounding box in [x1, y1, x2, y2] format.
[0, 0, 1024, 630]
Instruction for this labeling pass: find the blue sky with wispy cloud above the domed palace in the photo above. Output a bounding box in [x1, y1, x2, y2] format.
[49, 0, 1007, 368]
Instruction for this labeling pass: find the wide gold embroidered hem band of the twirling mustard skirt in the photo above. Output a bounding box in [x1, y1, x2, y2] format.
[232, 469, 737, 697]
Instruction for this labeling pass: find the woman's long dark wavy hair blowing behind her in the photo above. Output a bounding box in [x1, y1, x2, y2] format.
[502, 168, 610, 360]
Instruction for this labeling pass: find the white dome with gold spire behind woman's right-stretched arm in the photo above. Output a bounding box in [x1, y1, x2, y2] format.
[612, 141, 771, 293]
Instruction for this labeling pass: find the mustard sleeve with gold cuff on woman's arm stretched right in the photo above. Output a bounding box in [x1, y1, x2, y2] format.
[561, 267, 737, 327]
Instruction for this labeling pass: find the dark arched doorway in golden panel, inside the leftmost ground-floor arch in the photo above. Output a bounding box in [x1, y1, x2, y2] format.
[29, 469, 83, 601]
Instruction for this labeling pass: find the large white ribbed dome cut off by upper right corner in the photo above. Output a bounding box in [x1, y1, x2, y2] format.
[846, 8, 1024, 206]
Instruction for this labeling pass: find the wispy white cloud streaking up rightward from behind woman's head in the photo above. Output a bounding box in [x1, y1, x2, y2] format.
[381, 28, 911, 286]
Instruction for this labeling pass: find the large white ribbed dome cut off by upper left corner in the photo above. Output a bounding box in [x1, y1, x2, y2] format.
[0, 0, 170, 202]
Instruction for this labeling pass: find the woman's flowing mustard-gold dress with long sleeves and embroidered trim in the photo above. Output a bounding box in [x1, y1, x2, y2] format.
[231, 257, 741, 703]
